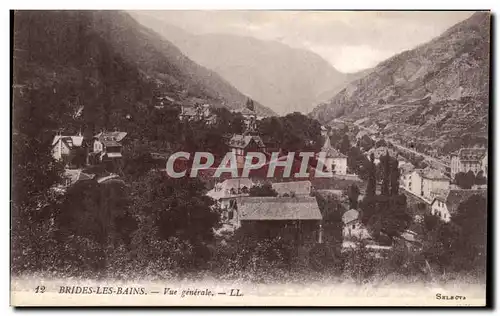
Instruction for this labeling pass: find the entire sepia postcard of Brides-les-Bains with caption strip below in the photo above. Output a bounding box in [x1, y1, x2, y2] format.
[10, 10, 493, 307]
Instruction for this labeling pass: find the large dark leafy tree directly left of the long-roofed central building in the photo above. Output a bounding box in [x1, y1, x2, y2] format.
[129, 173, 221, 271]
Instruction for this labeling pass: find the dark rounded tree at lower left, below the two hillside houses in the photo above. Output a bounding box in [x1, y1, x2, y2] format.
[55, 180, 137, 270]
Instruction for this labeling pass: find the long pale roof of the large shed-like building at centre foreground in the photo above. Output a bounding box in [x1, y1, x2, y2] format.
[238, 197, 322, 221]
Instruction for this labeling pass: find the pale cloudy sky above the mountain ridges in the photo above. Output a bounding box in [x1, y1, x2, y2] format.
[135, 11, 473, 72]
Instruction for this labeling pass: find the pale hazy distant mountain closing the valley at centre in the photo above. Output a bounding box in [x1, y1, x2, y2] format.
[127, 12, 348, 114]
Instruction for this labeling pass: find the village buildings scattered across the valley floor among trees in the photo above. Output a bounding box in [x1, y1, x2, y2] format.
[47, 96, 488, 266]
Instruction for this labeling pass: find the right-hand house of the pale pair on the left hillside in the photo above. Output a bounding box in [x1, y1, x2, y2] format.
[90, 131, 127, 164]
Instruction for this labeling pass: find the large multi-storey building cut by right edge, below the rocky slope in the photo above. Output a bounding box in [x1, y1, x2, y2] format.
[450, 148, 488, 179]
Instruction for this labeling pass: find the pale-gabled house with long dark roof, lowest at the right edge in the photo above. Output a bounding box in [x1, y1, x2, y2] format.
[431, 189, 487, 222]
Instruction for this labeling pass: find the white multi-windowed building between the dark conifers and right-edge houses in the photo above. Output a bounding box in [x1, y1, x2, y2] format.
[401, 168, 450, 202]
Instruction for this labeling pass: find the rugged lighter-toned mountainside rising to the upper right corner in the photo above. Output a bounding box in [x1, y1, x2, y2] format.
[311, 12, 490, 153]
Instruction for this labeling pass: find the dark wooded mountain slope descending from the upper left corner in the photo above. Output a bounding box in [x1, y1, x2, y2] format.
[13, 11, 275, 133]
